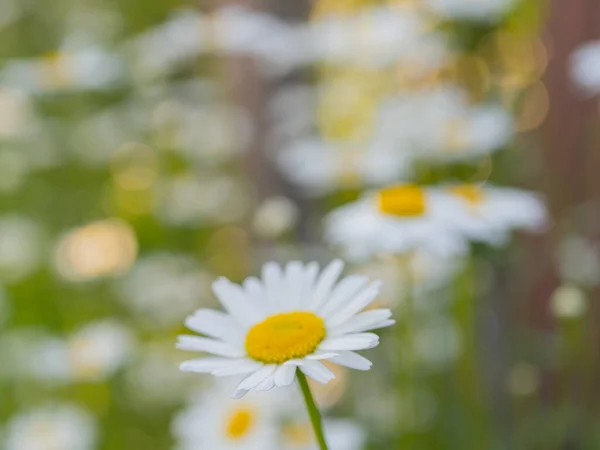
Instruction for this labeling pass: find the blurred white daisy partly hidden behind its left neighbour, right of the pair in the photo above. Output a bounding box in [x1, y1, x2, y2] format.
[436, 184, 548, 245]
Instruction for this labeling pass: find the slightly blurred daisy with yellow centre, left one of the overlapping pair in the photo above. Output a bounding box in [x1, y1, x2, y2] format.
[325, 185, 466, 260]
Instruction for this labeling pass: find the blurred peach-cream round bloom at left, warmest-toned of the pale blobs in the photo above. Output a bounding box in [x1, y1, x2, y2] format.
[54, 219, 137, 282]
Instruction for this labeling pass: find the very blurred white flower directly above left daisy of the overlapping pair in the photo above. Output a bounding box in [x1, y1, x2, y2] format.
[278, 139, 412, 195]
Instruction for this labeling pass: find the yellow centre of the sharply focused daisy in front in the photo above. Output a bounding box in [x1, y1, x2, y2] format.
[246, 312, 326, 364]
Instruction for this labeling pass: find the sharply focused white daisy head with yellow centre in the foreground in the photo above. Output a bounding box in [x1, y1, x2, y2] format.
[177, 260, 394, 398]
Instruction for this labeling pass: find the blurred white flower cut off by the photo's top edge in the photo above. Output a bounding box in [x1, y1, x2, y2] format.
[424, 0, 516, 22]
